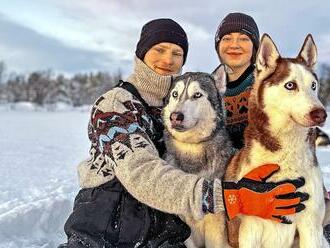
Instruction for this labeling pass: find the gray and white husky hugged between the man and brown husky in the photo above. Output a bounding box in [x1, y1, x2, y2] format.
[163, 66, 234, 248]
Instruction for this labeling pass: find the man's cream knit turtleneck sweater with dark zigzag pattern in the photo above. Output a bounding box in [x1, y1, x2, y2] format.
[78, 58, 224, 219]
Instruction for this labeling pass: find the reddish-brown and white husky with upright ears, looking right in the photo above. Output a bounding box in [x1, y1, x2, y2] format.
[225, 35, 329, 248]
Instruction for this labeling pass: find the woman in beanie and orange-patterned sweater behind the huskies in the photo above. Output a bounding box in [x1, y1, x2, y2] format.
[215, 13, 330, 242]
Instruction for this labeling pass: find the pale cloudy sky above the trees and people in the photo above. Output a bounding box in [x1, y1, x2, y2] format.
[0, 0, 330, 75]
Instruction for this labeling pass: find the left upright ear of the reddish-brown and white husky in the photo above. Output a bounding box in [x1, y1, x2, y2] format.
[256, 34, 281, 78]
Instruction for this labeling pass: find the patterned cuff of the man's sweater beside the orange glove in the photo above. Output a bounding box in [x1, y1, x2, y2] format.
[202, 179, 225, 214]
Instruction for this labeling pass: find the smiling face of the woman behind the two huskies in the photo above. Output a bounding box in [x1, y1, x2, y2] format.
[218, 33, 253, 71]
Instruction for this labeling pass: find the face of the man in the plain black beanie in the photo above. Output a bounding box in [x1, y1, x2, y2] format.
[143, 42, 183, 76]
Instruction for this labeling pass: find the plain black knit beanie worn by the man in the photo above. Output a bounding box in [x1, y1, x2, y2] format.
[135, 18, 188, 64]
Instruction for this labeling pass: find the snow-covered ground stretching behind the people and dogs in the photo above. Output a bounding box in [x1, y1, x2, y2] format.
[0, 107, 330, 248]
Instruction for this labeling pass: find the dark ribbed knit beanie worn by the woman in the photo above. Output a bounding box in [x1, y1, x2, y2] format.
[215, 13, 259, 62]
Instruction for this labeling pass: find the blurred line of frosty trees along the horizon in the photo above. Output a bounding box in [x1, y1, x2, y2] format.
[0, 62, 330, 106]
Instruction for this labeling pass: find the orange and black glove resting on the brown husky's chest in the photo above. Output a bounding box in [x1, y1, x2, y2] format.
[222, 164, 309, 224]
